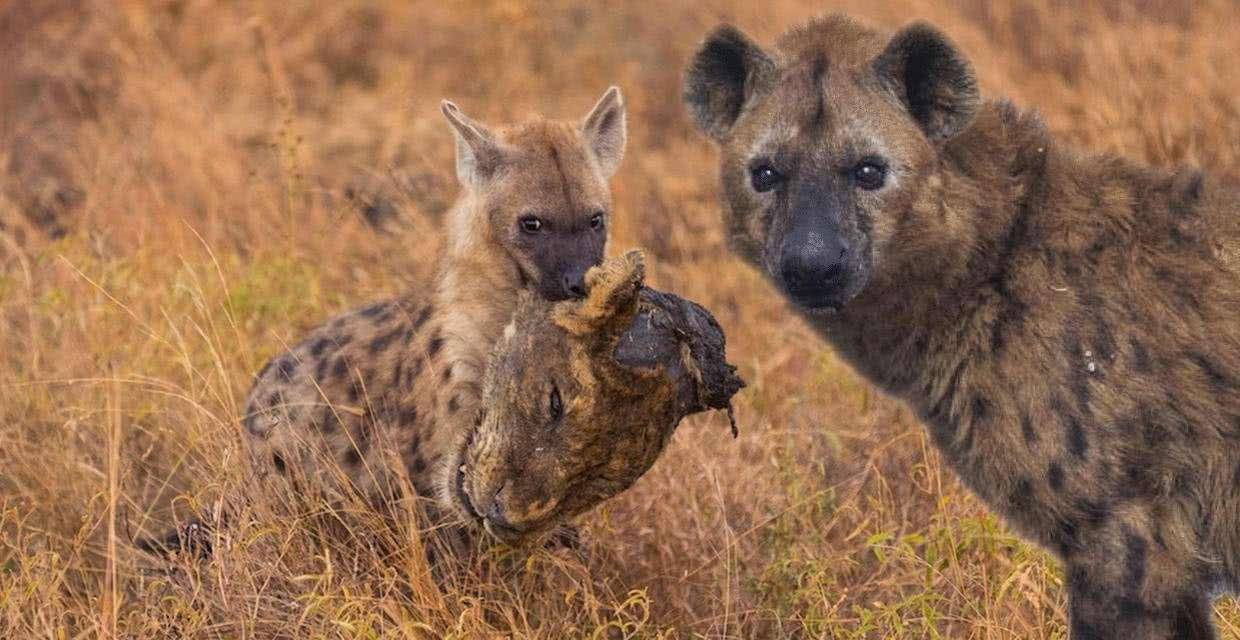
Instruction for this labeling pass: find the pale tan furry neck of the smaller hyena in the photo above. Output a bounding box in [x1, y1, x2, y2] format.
[434, 196, 522, 401]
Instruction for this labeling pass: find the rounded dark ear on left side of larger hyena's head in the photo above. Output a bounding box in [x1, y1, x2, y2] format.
[683, 25, 775, 141]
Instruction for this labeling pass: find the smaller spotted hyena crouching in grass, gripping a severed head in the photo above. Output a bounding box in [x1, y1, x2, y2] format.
[236, 87, 626, 525]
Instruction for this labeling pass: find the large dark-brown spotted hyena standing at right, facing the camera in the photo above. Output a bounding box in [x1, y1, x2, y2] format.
[684, 16, 1240, 639]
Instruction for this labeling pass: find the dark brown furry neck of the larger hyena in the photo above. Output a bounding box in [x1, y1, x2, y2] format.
[816, 103, 1050, 408]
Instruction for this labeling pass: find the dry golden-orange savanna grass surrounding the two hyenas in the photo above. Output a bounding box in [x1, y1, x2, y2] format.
[0, 0, 1240, 639]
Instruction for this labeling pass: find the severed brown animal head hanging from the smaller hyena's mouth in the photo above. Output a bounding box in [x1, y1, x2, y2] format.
[444, 253, 743, 542]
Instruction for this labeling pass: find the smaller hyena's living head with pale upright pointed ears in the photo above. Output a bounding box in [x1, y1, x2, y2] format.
[443, 87, 625, 300]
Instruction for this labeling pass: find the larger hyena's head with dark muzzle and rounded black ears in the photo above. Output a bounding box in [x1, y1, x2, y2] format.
[684, 16, 980, 310]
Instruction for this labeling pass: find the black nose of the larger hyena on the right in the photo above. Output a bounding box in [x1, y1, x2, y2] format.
[780, 232, 848, 306]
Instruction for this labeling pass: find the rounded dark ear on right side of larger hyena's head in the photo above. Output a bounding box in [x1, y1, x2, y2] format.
[874, 22, 981, 140]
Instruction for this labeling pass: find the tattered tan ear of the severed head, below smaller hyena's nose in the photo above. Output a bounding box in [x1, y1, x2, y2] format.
[553, 251, 646, 339]
